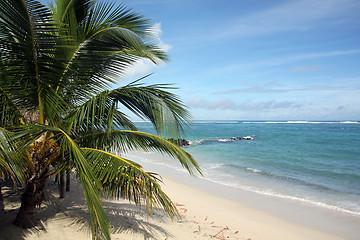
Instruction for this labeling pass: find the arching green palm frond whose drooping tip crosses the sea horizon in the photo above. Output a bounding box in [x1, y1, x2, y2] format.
[63, 77, 191, 135]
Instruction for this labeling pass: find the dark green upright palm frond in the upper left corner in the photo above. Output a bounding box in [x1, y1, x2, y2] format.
[0, 0, 62, 121]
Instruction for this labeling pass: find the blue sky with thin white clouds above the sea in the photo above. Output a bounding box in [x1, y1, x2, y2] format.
[46, 0, 360, 120]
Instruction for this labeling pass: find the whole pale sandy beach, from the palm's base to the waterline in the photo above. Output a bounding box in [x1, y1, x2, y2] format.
[0, 153, 360, 240]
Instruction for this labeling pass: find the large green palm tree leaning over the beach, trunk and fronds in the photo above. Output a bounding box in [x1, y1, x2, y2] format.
[0, 0, 200, 239]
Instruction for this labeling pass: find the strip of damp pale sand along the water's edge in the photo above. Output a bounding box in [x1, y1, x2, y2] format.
[129, 153, 360, 240]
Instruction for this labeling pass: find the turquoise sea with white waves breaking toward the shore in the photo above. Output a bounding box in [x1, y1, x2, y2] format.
[137, 121, 360, 217]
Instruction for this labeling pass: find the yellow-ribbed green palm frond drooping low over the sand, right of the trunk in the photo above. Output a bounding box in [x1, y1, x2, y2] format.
[82, 148, 179, 218]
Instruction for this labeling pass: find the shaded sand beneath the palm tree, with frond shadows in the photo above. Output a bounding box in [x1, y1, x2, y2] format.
[0, 179, 171, 240]
